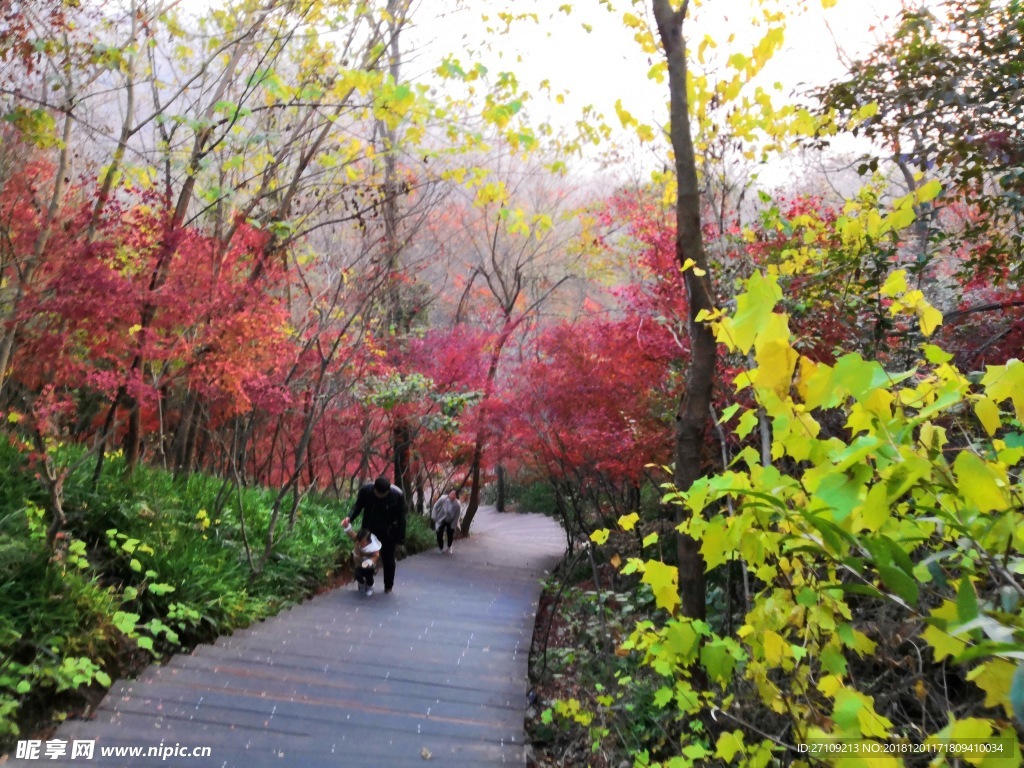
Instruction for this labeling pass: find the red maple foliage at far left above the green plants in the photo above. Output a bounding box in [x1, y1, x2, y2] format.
[11, 192, 287, 418]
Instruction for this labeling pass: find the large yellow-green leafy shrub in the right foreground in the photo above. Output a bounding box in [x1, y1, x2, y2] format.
[595, 264, 1024, 768]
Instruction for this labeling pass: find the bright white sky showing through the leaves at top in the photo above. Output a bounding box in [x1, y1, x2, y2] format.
[409, 0, 901, 141]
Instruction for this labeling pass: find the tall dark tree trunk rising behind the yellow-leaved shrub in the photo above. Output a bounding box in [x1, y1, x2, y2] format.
[651, 0, 716, 620]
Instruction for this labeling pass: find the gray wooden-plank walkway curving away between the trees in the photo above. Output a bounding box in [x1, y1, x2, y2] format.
[8, 507, 564, 768]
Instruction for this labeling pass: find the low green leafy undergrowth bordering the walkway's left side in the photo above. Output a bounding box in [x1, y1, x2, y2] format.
[0, 444, 431, 752]
